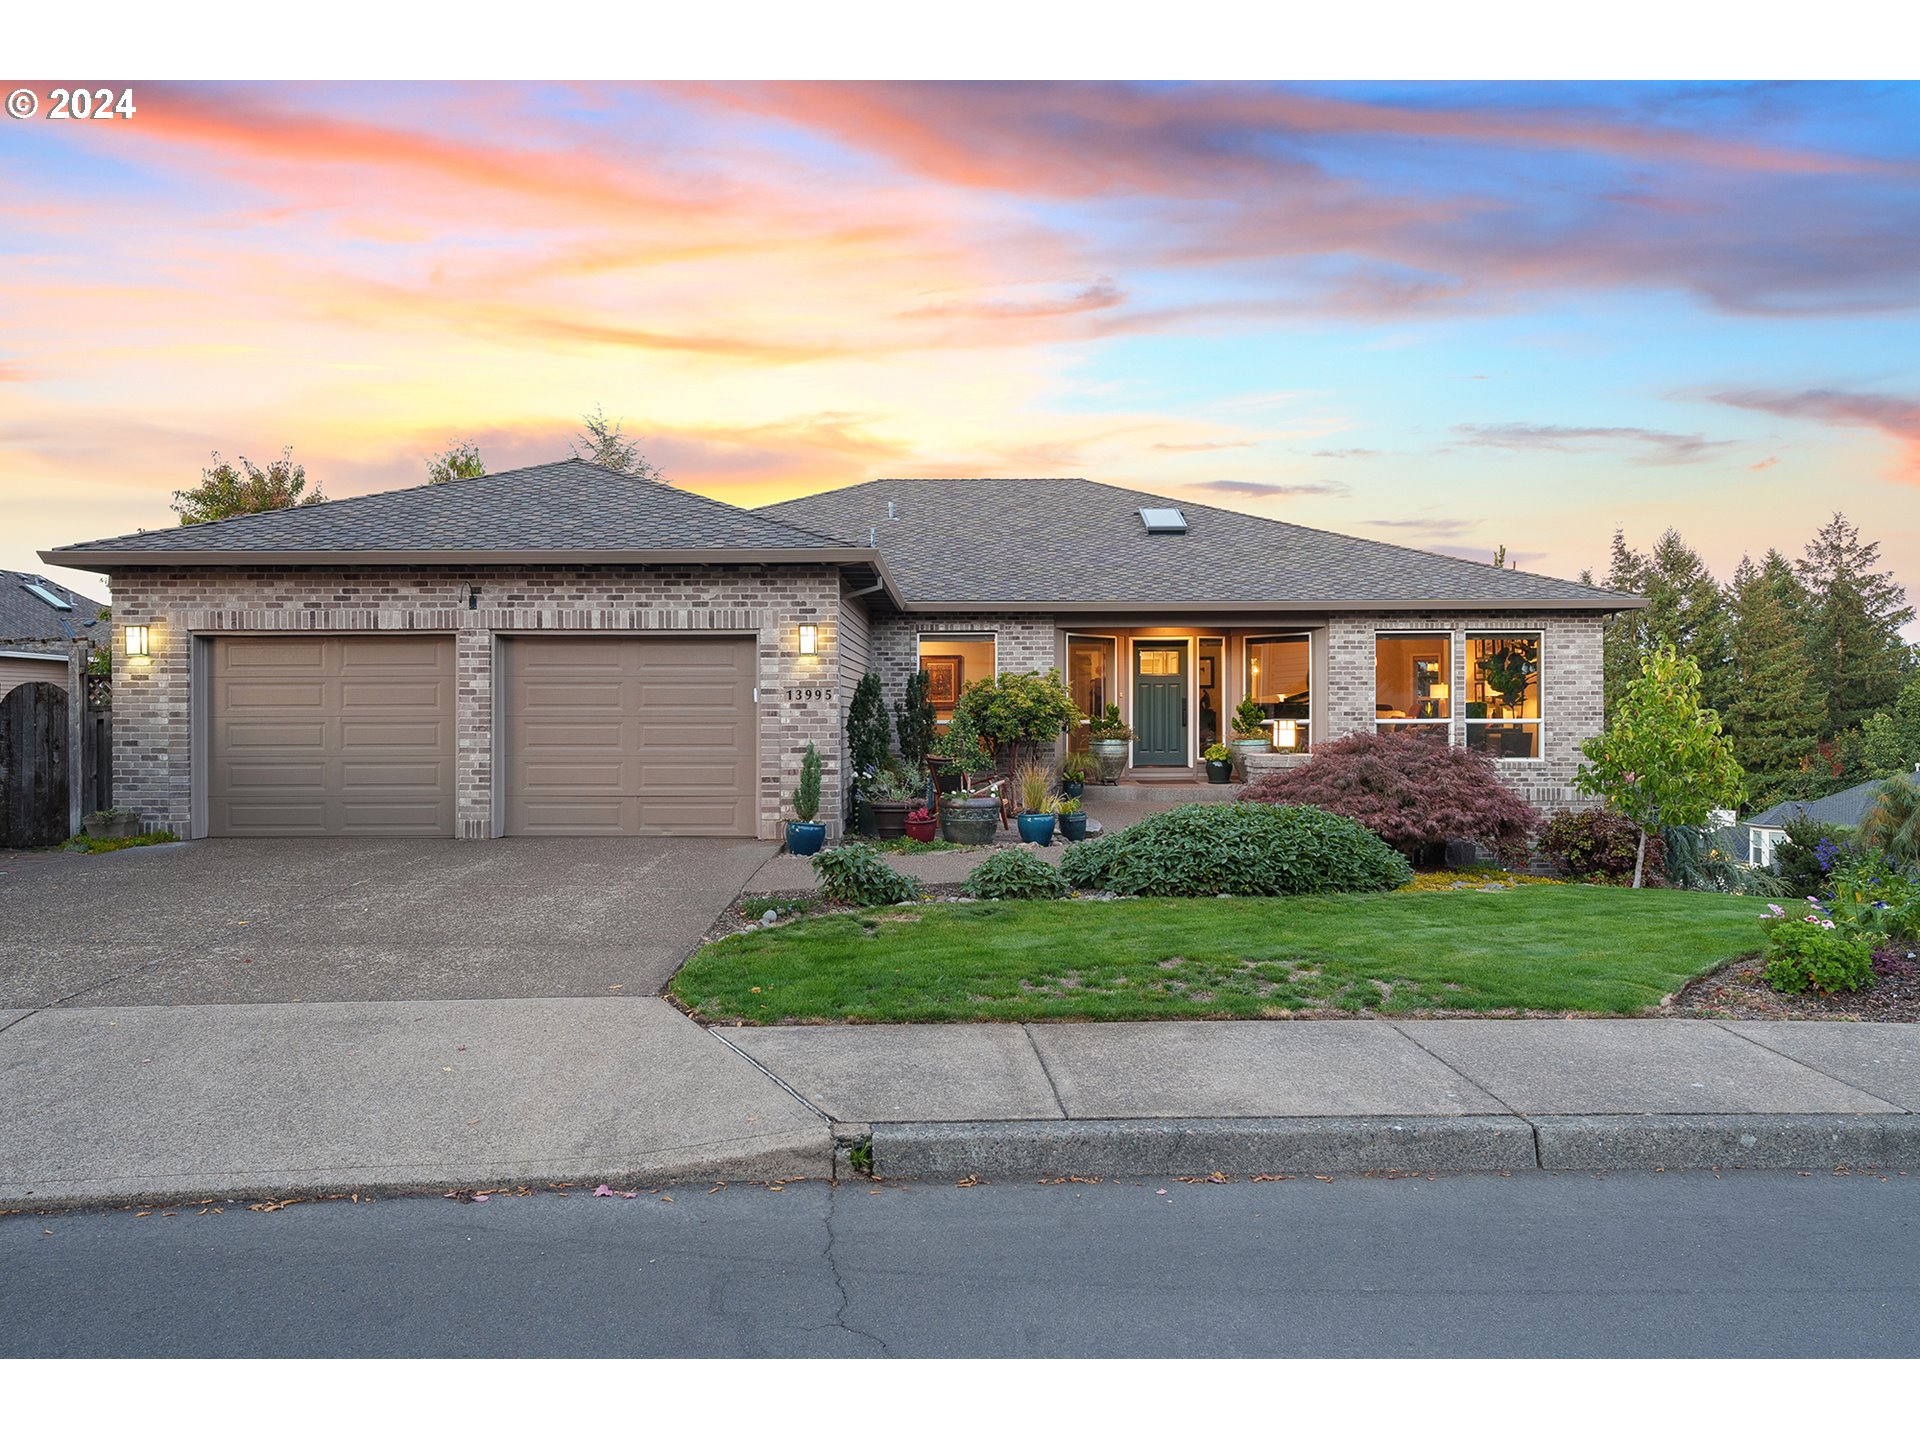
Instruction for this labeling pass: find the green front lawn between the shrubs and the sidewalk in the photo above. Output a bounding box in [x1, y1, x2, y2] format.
[668, 885, 1763, 1025]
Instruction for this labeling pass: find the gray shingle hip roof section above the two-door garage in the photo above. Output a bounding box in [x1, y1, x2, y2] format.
[46, 461, 845, 566]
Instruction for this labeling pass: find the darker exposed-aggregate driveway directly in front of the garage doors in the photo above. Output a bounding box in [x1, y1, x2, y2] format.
[0, 839, 776, 1010]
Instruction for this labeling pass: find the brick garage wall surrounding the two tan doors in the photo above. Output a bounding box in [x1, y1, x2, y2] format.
[113, 564, 843, 839]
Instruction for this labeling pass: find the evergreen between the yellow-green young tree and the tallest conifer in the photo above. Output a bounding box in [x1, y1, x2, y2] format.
[1724, 549, 1822, 799]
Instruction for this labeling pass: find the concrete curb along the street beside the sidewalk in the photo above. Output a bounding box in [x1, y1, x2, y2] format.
[872, 1116, 1920, 1181]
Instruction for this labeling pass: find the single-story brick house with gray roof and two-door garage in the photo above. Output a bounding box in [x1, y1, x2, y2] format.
[46, 461, 1642, 839]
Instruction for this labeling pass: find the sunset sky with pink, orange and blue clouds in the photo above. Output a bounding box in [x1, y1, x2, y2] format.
[0, 81, 1920, 622]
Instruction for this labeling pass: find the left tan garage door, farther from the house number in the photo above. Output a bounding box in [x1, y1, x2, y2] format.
[207, 636, 453, 835]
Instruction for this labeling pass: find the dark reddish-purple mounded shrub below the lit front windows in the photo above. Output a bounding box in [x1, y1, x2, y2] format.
[1240, 733, 1540, 864]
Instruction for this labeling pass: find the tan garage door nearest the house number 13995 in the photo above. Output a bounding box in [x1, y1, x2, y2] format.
[503, 636, 756, 835]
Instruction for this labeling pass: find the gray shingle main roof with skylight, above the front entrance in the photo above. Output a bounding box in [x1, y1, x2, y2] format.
[758, 480, 1642, 611]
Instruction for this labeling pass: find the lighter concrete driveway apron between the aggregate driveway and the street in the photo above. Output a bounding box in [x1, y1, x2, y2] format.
[0, 996, 831, 1208]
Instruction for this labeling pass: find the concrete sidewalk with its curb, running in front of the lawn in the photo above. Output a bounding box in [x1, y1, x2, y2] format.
[720, 1020, 1920, 1179]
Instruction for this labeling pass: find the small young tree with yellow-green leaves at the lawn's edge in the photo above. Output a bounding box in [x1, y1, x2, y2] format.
[1574, 645, 1743, 889]
